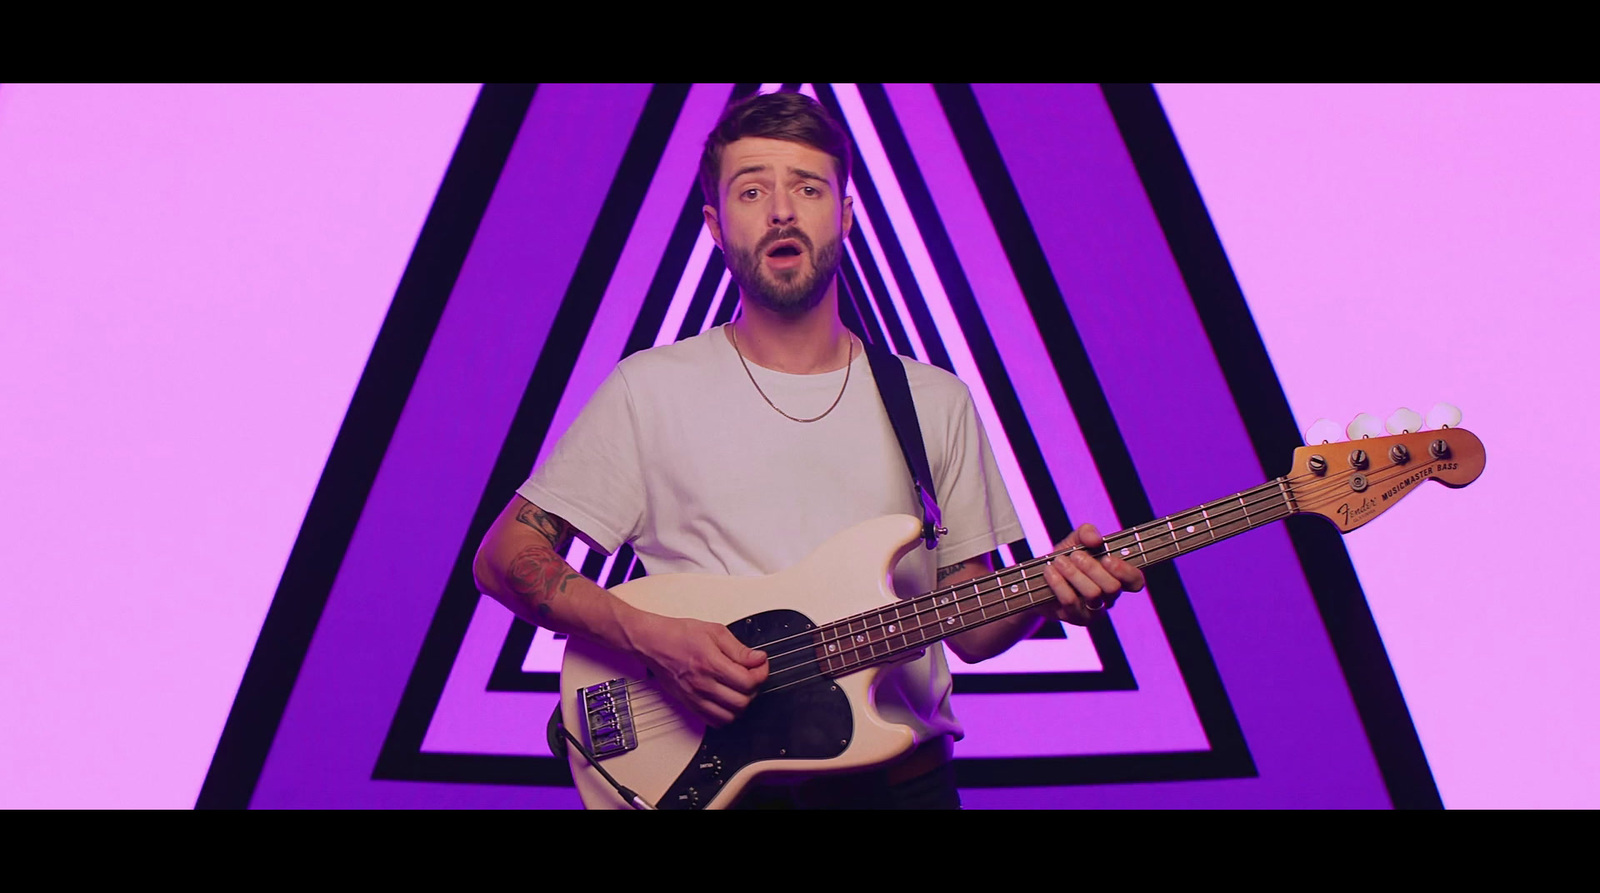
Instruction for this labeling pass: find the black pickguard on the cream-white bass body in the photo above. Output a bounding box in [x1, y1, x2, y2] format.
[656, 611, 854, 810]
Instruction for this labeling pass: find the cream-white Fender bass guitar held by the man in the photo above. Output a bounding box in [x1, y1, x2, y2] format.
[560, 416, 1485, 810]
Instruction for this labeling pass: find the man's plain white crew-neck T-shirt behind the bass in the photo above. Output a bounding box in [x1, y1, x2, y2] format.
[517, 328, 1022, 741]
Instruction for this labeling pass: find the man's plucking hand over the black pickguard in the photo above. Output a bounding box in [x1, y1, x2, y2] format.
[635, 616, 768, 725]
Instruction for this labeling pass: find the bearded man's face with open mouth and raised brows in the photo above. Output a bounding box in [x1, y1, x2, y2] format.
[706, 138, 853, 315]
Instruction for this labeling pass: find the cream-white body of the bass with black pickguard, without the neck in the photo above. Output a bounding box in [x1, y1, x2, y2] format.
[562, 515, 938, 808]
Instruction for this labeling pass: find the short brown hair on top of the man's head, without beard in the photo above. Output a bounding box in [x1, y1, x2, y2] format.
[699, 93, 850, 210]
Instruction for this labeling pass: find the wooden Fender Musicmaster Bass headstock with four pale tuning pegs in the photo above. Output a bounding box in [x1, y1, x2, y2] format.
[1283, 403, 1485, 533]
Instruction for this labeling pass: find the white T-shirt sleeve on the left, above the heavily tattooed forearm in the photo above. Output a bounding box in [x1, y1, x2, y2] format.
[517, 368, 645, 554]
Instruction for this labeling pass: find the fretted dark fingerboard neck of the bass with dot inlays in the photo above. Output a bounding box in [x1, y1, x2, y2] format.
[814, 477, 1298, 675]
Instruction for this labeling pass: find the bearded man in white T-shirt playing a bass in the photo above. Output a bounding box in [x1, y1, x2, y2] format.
[474, 93, 1144, 807]
